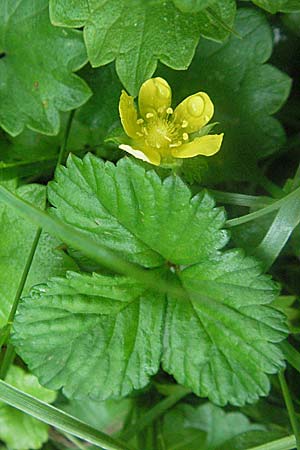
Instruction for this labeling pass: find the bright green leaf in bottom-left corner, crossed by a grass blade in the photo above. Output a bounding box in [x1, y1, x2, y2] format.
[0, 366, 56, 450]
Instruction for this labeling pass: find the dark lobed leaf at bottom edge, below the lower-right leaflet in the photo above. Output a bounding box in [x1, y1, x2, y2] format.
[163, 403, 264, 450]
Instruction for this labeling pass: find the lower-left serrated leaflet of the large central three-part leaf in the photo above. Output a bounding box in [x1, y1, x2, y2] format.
[14, 272, 165, 400]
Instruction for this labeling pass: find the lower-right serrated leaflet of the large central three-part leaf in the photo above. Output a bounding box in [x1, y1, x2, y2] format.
[163, 251, 287, 405]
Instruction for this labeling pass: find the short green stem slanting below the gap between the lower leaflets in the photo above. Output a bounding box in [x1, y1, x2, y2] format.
[121, 389, 190, 441]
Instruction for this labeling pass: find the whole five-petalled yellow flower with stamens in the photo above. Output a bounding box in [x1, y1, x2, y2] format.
[119, 78, 223, 166]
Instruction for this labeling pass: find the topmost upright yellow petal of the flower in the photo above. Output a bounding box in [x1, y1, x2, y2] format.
[139, 77, 172, 118]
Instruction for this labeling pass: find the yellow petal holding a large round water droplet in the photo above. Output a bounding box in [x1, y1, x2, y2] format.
[174, 92, 214, 133]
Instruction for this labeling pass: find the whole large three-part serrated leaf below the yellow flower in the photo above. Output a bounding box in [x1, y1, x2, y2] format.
[13, 155, 287, 405]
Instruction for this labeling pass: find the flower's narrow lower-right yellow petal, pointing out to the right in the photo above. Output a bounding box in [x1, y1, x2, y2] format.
[172, 133, 224, 158]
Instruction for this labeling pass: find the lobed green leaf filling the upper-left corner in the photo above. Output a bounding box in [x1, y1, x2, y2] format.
[0, 0, 90, 136]
